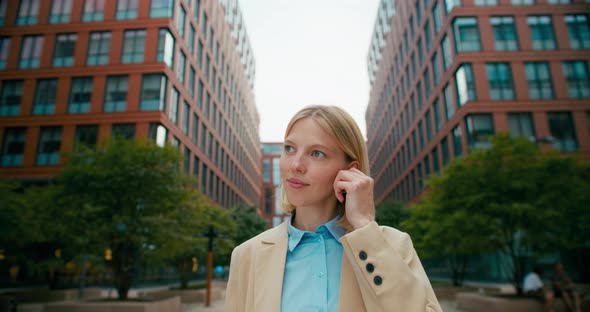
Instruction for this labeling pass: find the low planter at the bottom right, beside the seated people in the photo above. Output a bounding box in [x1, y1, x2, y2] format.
[456, 293, 590, 312]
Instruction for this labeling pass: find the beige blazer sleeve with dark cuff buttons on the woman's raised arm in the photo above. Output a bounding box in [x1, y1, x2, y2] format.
[341, 222, 442, 312]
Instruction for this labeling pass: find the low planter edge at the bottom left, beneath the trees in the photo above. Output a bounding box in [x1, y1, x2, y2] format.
[43, 297, 182, 312]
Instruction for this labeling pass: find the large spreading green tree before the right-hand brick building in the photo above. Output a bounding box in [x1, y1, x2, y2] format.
[407, 134, 590, 293]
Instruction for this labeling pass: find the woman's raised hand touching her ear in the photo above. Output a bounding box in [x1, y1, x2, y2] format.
[334, 167, 375, 230]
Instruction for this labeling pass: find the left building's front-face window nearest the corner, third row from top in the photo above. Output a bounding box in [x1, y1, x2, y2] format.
[139, 74, 168, 112]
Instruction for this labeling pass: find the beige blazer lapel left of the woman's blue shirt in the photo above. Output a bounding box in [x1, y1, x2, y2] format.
[254, 220, 289, 311]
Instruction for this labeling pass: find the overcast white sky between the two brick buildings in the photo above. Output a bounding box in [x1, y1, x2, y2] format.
[239, 0, 379, 142]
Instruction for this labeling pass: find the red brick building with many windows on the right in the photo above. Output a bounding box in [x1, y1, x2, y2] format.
[365, 0, 590, 202]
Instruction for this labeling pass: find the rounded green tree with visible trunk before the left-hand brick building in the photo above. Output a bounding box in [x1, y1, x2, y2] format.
[57, 138, 190, 300]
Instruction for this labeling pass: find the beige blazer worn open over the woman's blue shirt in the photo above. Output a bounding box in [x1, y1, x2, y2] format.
[225, 221, 442, 312]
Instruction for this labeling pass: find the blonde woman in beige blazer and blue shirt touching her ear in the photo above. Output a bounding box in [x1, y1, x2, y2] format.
[226, 106, 442, 312]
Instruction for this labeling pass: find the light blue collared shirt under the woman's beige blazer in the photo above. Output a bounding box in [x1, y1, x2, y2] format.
[281, 218, 346, 312]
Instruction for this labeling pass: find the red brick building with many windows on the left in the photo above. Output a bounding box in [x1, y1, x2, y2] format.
[0, 0, 261, 207]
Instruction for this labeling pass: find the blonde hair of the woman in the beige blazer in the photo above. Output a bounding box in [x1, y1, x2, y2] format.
[281, 105, 370, 228]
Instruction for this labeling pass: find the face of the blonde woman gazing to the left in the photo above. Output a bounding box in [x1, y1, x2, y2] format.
[280, 118, 349, 208]
